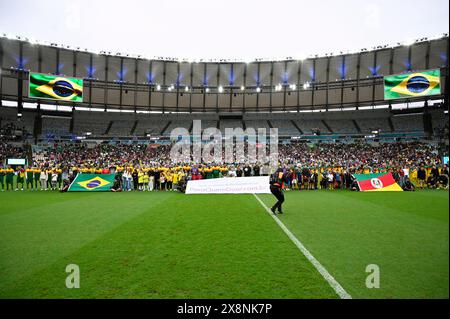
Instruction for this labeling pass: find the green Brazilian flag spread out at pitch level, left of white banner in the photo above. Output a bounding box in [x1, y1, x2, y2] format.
[67, 173, 116, 192]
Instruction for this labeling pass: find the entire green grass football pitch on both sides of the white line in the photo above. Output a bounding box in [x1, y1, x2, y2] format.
[0, 190, 449, 298]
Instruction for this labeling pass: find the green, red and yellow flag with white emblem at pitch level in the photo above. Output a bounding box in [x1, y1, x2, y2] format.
[353, 173, 403, 192]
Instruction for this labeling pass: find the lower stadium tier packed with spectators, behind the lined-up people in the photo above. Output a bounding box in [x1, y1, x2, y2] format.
[0, 141, 448, 169]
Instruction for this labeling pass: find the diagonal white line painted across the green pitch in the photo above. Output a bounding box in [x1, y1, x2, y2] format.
[253, 194, 352, 299]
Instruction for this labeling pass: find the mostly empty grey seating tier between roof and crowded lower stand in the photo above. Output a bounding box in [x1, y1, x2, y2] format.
[0, 107, 448, 140]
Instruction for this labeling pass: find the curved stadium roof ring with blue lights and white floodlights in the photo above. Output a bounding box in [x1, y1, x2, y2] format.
[0, 35, 449, 112]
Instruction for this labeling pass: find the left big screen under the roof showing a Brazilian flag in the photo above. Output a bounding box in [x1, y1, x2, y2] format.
[28, 73, 83, 102]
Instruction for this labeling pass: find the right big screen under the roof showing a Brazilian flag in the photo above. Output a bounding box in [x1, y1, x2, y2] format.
[384, 69, 441, 100]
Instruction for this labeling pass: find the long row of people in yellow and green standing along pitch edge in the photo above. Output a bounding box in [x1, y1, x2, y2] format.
[0, 164, 449, 191]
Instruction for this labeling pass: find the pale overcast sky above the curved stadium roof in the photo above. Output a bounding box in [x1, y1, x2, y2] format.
[0, 0, 449, 61]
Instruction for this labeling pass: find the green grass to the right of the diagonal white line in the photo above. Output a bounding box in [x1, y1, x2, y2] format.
[261, 190, 449, 298]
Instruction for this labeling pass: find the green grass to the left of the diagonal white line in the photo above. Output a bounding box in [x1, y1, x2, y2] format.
[0, 192, 337, 298]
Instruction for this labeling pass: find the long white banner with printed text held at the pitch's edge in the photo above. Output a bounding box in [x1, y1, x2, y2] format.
[186, 176, 270, 194]
